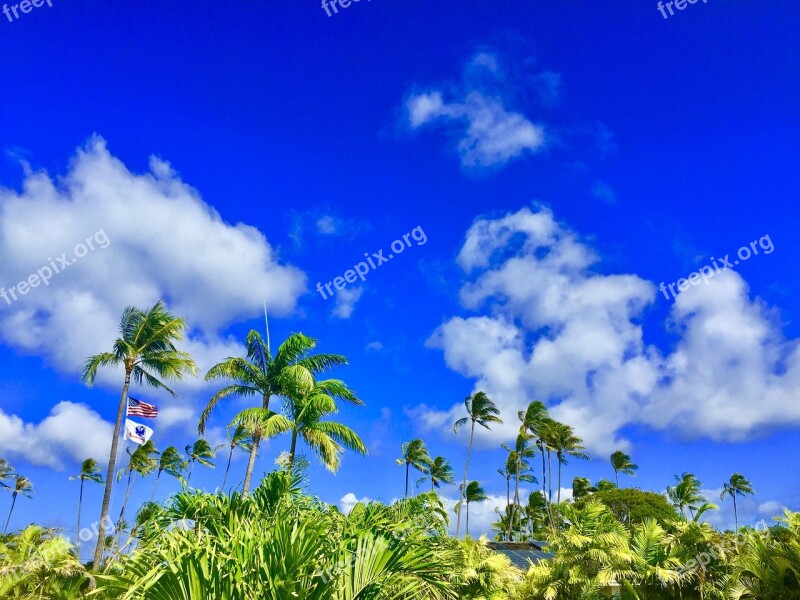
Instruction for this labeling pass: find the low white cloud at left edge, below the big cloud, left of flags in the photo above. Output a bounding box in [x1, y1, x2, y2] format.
[0, 401, 114, 470]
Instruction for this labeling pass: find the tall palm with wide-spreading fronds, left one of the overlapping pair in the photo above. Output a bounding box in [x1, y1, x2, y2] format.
[202, 330, 347, 495]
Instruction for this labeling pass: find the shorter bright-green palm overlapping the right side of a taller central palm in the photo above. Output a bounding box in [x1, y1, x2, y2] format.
[282, 365, 367, 473]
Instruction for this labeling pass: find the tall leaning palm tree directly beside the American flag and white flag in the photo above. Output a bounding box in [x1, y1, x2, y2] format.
[83, 300, 197, 568]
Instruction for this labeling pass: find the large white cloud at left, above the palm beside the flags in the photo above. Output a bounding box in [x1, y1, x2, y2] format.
[0, 137, 306, 372]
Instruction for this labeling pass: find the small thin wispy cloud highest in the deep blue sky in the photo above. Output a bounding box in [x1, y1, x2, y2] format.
[405, 52, 558, 167]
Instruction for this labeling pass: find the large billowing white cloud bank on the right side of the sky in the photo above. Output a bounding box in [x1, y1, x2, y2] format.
[416, 208, 800, 455]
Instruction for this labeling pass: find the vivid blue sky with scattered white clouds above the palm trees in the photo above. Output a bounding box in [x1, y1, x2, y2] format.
[0, 0, 800, 544]
